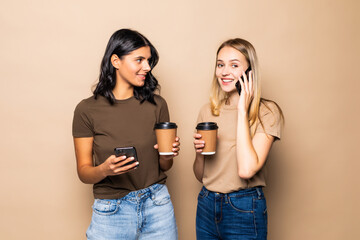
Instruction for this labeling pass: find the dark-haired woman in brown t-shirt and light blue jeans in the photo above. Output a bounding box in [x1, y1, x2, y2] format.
[73, 29, 180, 240]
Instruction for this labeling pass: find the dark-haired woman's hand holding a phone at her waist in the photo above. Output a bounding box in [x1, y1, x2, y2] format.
[100, 155, 139, 177]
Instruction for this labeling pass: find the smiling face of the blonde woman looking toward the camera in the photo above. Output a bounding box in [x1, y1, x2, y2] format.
[215, 46, 249, 93]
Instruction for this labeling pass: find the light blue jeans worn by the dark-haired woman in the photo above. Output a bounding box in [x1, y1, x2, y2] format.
[86, 184, 177, 240]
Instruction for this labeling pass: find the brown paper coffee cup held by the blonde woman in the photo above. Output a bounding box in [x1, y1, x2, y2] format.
[196, 122, 219, 155]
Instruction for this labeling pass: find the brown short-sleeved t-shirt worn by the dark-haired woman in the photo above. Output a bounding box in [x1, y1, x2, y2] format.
[72, 95, 169, 199]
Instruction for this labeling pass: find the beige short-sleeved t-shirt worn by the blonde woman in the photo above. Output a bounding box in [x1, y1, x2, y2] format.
[197, 102, 281, 193]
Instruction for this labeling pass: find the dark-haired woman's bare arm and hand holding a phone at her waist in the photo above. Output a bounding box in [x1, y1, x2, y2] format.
[74, 137, 138, 184]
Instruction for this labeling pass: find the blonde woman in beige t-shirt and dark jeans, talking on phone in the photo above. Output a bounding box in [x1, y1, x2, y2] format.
[193, 38, 283, 239]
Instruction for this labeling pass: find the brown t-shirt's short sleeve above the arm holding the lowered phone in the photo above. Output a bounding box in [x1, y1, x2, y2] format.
[72, 100, 94, 138]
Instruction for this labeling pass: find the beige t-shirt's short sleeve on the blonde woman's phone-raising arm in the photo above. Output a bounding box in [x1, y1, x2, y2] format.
[255, 102, 281, 140]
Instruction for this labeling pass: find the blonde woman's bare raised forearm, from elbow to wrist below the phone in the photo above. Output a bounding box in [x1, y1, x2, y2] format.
[236, 113, 260, 179]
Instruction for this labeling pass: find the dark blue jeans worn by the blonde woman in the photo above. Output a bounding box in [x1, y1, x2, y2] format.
[196, 187, 267, 240]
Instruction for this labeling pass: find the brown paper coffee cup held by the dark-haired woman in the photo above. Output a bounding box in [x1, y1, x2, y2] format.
[154, 122, 177, 155]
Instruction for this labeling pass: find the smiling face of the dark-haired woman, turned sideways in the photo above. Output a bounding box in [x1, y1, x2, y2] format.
[112, 46, 151, 88]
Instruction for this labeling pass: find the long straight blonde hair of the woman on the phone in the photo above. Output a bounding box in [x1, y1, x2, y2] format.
[210, 38, 284, 137]
